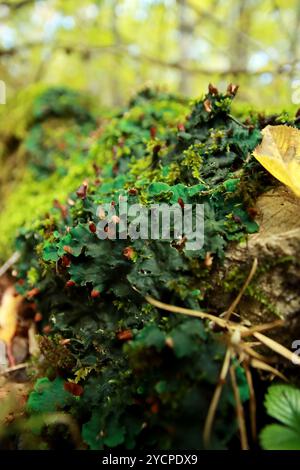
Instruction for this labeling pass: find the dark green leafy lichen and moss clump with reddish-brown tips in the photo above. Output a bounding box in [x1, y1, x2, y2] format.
[5, 86, 300, 449]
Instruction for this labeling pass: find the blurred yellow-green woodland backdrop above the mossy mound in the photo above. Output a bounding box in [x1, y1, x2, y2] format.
[0, 0, 300, 111]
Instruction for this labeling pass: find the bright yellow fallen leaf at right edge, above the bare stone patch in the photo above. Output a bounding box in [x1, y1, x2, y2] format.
[253, 126, 300, 196]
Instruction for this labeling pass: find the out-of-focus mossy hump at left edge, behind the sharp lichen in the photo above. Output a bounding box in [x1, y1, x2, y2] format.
[0, 88, 94, 260]
